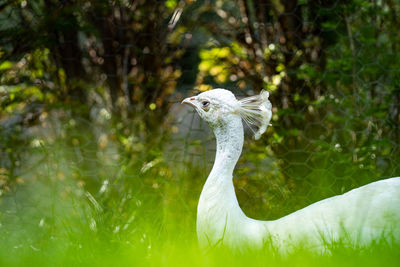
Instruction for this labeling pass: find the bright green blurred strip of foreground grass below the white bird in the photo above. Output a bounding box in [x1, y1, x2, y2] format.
[0, 230, 400, 266]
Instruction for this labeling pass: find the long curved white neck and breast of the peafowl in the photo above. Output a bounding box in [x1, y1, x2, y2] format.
[197, 114, 265, 247]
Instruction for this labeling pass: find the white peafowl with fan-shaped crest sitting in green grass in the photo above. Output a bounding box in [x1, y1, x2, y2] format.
[182, 88, 400, 253]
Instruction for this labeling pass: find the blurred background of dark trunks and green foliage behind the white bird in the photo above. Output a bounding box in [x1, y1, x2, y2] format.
[0, 0, 400, 266]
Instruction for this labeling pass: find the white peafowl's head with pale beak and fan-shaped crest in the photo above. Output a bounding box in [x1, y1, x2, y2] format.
[182, 89, 272, 139]
